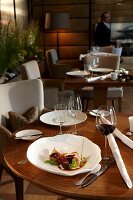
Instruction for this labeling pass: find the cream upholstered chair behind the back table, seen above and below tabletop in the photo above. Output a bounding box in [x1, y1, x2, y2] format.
[81, 54, 123, 112]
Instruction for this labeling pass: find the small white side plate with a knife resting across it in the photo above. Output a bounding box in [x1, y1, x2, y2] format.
[15, 129, 42, 140]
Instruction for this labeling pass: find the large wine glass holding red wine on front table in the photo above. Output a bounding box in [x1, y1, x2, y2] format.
[96, 105, 117, 162]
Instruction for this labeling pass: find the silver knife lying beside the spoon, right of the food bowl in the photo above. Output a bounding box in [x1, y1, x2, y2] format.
[81, 165, 111, 188]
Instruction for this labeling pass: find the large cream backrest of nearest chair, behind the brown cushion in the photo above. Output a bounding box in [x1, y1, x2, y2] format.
[0, 79, 44, 127]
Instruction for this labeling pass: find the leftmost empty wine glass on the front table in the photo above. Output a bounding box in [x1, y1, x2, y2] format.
[54, 104, 67, 135]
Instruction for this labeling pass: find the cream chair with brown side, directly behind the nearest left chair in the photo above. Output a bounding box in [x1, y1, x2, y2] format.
[21, 60, 73, 109]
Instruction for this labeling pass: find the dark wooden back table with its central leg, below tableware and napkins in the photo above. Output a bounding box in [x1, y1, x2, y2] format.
[64, 76, 133, 109]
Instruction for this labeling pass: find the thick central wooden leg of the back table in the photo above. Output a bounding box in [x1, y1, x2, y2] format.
[93, 87, 108, 109]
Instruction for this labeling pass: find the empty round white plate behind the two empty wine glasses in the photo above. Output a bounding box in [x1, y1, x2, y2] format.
[40, 111, 87, 126]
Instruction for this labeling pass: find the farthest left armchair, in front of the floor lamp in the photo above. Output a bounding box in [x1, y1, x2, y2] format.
[46, 49, 73, 79]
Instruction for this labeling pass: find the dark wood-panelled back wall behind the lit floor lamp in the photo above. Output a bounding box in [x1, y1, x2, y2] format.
[31, 0, 133, 67]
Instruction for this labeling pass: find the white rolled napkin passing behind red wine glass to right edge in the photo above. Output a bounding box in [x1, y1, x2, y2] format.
[101, 116, 133, 149]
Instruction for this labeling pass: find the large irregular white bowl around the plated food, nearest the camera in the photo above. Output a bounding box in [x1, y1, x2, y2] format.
[27, 134, 101, 176]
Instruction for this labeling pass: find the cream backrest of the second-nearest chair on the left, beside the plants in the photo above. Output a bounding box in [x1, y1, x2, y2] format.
[21, 60, 41, 80]
